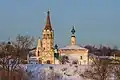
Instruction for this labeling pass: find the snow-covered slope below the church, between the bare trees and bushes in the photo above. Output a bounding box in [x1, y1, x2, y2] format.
[21, 64, 88, 80]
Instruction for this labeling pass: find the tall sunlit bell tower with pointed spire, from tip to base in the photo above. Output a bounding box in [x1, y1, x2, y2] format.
[42, 11, 54, 64]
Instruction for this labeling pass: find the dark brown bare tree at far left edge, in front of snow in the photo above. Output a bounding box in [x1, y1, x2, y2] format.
[0, 42, 19, 77]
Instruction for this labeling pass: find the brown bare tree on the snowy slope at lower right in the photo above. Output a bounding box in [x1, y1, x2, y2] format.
[82, 58, 111, 80]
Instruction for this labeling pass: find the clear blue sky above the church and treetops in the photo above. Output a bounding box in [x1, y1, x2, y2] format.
[0, 0, 120, 47]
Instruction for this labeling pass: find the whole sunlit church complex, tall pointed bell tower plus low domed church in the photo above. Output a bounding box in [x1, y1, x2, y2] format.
[28, 11, 88, 65]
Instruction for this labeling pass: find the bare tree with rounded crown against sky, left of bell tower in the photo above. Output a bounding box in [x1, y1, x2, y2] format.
[14, 35, 34, 63]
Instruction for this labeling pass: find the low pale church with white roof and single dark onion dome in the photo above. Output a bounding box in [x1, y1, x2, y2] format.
[59, 26, 89, 65]
